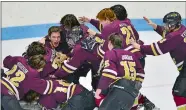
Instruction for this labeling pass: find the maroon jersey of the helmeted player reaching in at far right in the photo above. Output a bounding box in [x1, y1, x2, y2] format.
[140, 25, 186, 71]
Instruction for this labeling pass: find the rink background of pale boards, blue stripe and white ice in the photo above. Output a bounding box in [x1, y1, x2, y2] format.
[1, 2, 186, 110]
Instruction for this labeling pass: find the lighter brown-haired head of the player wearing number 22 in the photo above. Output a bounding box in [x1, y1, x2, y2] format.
[28, 54, 46, 70]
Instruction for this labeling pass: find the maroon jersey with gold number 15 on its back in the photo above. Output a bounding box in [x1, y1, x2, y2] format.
[98, 49, 145, 90]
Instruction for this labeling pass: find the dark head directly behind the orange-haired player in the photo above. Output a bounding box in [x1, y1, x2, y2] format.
[110, 4, 128, 20]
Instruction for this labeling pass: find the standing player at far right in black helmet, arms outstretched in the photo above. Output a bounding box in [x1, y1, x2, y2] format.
[131, 12, 186, 110]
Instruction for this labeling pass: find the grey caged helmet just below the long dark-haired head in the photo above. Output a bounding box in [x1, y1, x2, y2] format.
[66, 26, 83, 48]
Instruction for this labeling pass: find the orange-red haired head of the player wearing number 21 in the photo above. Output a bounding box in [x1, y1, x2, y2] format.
[96, 8, 117, 22]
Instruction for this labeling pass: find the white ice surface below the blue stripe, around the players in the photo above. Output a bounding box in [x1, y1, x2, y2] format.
[2, 31, 178, 110]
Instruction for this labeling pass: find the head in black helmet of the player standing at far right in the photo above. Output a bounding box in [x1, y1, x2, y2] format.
[163, 12, 182, 31]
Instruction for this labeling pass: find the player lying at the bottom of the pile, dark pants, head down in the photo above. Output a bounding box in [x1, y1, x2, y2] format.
[22, 81, 95, 110]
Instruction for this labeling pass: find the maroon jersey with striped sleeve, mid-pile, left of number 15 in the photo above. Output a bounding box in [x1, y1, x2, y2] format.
[55, 44, 101, 78]
